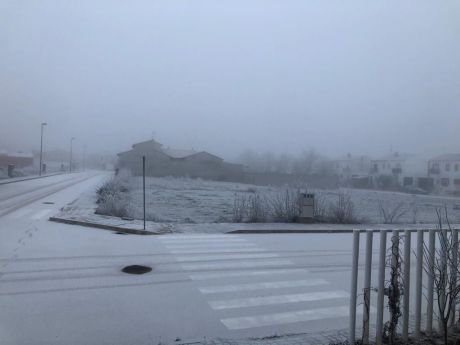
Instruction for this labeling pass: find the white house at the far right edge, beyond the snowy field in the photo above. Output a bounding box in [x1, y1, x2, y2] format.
[428, 153, 460, 194]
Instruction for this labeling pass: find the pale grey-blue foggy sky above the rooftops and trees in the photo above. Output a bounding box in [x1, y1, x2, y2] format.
[0, 0, 460, 158]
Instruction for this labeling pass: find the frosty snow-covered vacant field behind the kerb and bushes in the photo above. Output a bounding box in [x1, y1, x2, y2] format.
[106, 177, 460, 224]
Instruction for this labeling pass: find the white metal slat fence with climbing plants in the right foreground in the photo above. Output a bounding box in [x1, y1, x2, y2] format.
[349, 229, 458, 345]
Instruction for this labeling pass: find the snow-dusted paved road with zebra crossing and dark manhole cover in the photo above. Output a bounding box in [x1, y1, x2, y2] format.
[0, 176, 422, 345]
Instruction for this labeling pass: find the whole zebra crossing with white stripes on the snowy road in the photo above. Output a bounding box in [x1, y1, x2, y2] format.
[160, 234, 356, 331]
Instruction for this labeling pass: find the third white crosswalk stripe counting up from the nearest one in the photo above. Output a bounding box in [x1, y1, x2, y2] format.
[199, 279, 329, 294]
